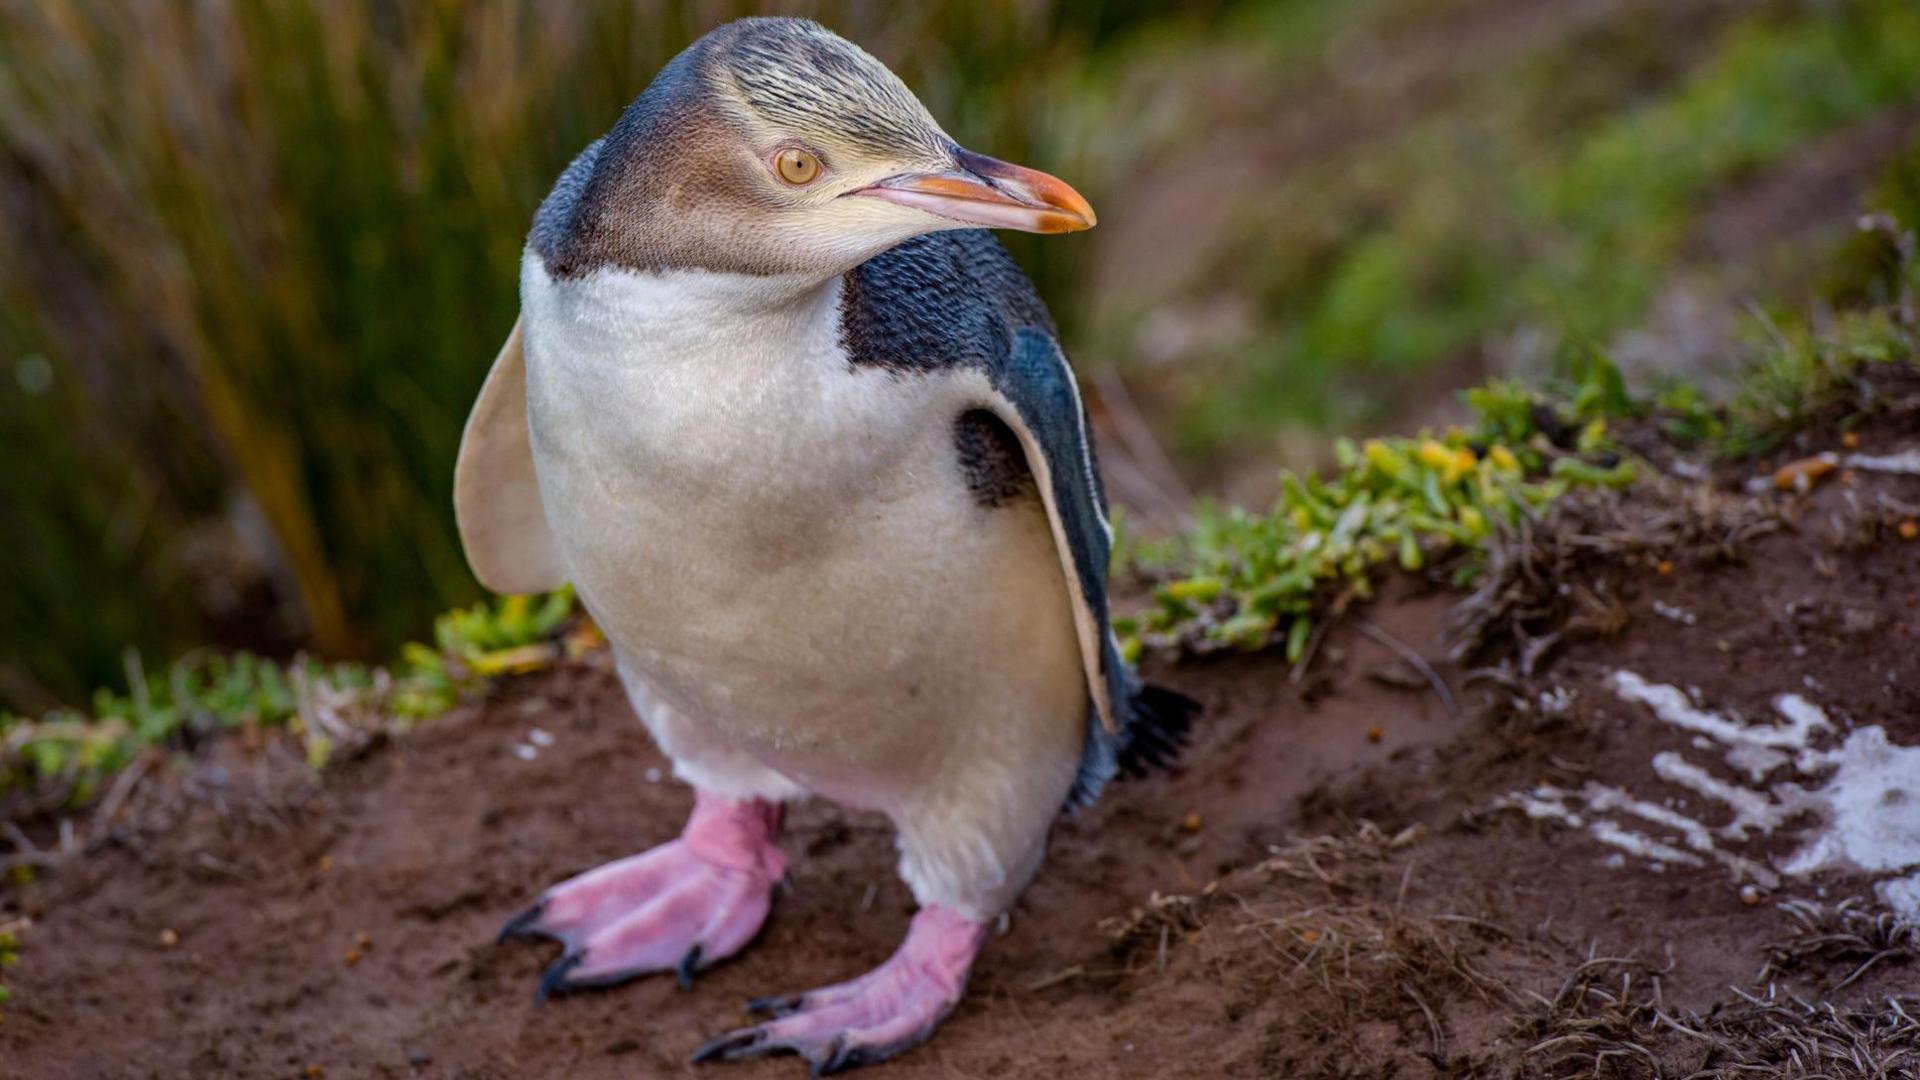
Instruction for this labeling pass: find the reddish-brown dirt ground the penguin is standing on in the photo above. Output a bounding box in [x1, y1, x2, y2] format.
[0, 377, 1920, 1080]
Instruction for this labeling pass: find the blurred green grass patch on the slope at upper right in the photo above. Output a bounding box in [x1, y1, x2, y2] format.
[1152, 0, 1920, 452]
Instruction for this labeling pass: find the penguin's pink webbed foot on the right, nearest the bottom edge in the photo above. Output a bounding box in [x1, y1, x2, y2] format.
[693, 905, 987, 1076]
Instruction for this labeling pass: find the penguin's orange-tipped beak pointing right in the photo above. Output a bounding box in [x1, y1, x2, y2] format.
[849, 148, 1098, 233]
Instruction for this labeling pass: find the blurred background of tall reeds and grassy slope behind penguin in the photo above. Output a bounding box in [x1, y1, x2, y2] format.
[0, 0, 1920, 713]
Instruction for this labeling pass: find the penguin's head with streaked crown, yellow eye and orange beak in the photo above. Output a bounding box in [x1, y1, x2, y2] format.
[536, 17, 1094, 279]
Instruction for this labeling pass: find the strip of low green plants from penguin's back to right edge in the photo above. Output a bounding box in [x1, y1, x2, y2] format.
[1116, 215, 1920, 645]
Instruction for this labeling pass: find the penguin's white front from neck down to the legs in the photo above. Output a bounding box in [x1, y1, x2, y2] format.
[526, 263, 1087, 811]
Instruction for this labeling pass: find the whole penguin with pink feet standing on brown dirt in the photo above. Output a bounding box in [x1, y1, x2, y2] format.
[455, 17, 1196, 1074]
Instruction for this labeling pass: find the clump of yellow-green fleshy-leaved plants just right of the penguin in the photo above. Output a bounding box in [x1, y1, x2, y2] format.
[1116, 354, 1634, 661]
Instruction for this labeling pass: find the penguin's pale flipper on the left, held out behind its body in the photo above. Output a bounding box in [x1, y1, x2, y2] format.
[453, 319, 566, 594]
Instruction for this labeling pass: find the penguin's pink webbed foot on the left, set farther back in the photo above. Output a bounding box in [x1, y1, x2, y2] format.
[499, 792, 787, 997]
